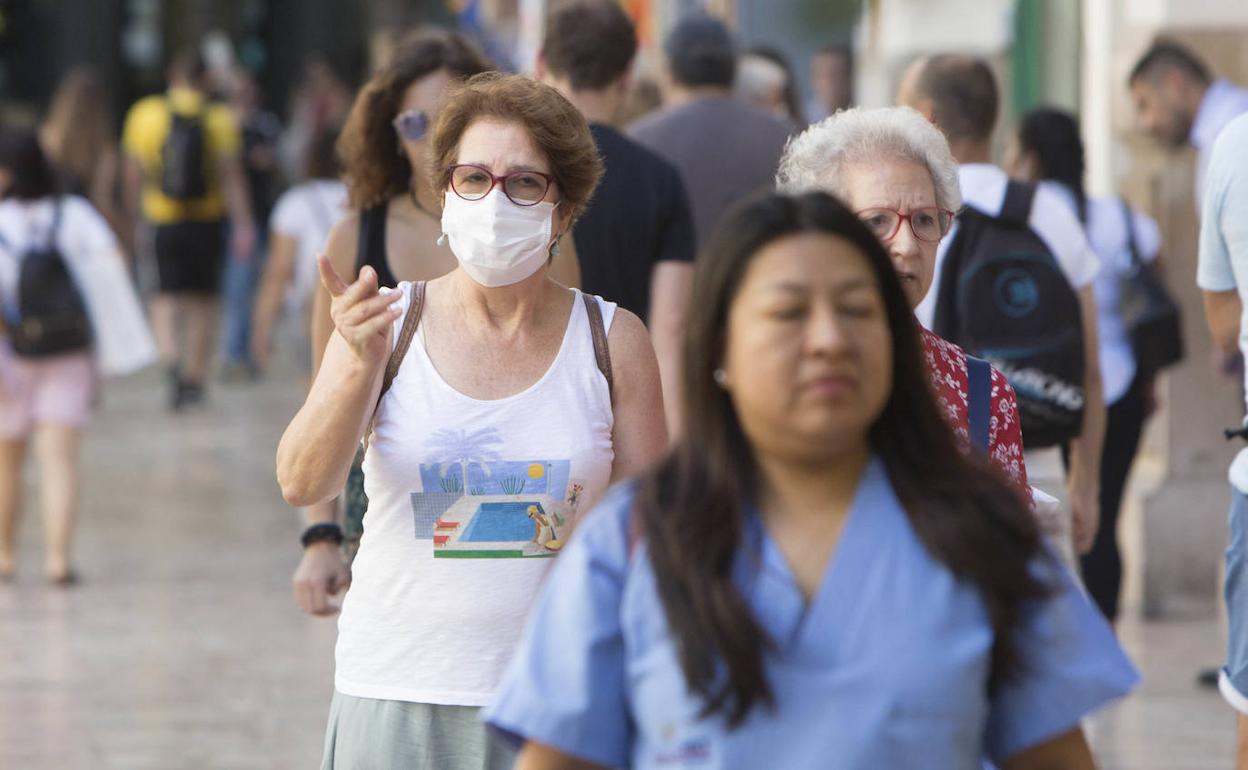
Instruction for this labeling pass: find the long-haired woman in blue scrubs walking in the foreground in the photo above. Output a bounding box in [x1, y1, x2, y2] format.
[487, 193, 1136, 770]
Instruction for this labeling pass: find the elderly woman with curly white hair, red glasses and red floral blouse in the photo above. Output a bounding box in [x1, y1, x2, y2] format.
[776, 107, 1031, 498]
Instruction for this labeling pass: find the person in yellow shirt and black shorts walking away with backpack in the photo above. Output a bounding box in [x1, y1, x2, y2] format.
[121, 50, 255, 411]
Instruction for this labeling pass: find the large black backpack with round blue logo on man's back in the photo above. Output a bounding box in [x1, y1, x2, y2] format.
[932, 181, 1085, 449]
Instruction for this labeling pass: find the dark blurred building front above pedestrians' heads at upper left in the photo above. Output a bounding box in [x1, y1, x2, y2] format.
[0, 0, 454, 124]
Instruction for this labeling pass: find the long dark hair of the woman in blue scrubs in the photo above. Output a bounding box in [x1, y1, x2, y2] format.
[635, 192, 1048, 726]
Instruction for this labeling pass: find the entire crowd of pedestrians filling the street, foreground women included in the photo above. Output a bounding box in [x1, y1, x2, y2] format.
[0, 0, 1248, 770]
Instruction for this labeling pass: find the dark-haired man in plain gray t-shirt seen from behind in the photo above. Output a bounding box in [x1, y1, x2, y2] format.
[629, 15, 791, 245]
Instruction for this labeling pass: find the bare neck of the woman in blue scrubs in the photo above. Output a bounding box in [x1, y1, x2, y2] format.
[759, 439, 871, 526]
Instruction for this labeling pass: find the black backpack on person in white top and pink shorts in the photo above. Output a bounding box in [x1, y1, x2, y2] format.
[0, 201, 91, 358]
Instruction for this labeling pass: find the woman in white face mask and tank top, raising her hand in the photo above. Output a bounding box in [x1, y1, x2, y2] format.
[277, 74, 666, 770]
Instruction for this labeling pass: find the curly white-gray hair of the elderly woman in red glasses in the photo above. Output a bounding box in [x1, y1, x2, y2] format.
[776, 107, 962, 211]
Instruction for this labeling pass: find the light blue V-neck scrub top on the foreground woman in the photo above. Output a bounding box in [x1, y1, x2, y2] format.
[485, 459, 1137, 770]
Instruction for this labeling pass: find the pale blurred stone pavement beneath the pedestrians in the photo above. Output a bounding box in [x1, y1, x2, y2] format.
[0, 364, 1234, 770]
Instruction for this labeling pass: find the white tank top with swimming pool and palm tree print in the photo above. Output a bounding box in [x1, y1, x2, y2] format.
[334, 283, 615, 706]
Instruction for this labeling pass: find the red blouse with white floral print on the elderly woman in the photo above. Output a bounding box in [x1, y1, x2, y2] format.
[922, 329, 1031, 503]
